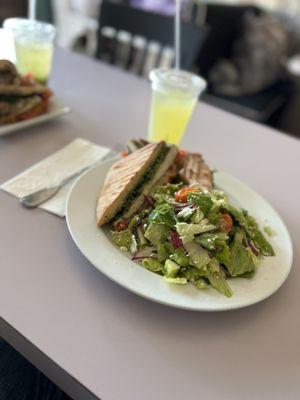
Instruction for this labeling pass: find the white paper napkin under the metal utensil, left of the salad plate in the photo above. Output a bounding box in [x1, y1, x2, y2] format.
[1, 138, 110, 217]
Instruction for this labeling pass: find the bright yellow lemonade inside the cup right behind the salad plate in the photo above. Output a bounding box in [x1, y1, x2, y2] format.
[149, 92, 197, 144]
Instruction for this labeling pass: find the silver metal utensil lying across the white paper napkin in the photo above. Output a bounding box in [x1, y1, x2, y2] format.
[20, 146, 119, 208]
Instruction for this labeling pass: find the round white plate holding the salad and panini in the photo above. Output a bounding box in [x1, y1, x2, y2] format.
[67, 161, 293, 311]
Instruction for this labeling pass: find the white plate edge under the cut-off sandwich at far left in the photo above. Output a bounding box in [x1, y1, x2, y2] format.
[0, 100, 71, 136]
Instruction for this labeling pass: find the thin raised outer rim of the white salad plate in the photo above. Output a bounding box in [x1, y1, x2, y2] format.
[65, 160, 294, 312]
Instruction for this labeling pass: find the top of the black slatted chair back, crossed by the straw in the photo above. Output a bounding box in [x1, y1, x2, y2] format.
[96, 0, 206, 70]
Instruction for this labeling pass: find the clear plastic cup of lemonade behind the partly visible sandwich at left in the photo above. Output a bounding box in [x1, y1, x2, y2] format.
[3, 18, 55, 83]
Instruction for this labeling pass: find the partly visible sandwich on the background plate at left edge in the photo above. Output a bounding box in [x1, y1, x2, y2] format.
[0, 60, 52, 125]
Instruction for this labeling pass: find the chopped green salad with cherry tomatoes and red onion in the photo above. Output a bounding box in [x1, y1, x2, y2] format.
[111, 184, 274, 297]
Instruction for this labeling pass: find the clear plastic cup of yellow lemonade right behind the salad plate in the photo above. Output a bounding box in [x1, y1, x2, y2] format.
[149, 68, 206, 144]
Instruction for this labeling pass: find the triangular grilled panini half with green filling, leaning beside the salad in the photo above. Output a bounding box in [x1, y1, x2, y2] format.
[97, 141, 178, 226]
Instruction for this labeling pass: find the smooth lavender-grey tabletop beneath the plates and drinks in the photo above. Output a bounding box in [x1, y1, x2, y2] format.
[0, 51, 300, 400]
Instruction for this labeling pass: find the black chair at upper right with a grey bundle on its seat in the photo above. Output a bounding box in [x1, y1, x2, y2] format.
[192, 4, 291, 123]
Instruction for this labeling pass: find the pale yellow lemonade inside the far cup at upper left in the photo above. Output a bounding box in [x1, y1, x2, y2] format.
[15, 40, 53, 83]
